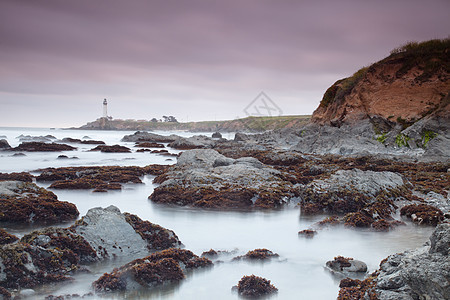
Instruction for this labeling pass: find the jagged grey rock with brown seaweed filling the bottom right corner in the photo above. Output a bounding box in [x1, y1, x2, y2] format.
[338, 223, 450, 300]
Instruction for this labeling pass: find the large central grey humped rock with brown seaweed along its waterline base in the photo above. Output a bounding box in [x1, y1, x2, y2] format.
[149, 149, 294, 209]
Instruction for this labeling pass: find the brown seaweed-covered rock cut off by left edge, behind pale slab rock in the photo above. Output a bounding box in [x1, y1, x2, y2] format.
[0, 181, 79, 223]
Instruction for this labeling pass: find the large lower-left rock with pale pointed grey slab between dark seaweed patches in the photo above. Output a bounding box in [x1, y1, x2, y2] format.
[0, 206, 181, 289]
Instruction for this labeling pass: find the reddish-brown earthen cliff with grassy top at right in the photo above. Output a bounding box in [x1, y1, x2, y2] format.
[312, 39, 450, 131]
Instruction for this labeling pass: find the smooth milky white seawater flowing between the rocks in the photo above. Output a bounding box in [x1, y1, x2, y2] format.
[0, 128, 432, 300]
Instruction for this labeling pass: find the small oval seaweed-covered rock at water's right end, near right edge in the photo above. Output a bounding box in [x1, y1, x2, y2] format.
[400, 204, 444, 225]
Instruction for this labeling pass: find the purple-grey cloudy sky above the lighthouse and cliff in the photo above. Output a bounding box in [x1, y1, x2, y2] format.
[0, 0, 450, 127]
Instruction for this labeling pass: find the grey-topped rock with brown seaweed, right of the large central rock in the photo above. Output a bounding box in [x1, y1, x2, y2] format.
[299, 169, 406, 230]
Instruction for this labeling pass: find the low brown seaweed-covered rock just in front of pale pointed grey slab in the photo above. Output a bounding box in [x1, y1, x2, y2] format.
[93, 248, 212, 292]
